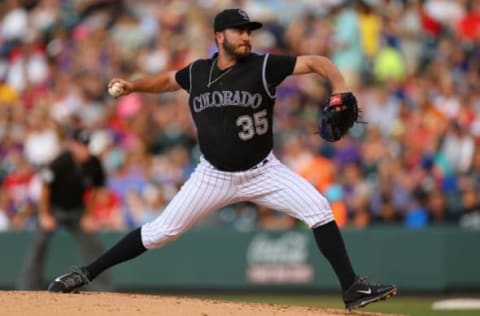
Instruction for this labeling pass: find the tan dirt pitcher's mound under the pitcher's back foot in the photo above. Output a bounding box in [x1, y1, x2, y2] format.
[0, 291, 398, 316]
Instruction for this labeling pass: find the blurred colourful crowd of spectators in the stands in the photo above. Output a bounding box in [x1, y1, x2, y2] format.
[0, 0, 480, 231]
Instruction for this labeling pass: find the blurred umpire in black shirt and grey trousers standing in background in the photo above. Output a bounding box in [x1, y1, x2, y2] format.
[19, 129, 110, 290]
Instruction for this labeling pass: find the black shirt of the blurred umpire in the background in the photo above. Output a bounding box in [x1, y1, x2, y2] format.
[41, 151, 105, 210]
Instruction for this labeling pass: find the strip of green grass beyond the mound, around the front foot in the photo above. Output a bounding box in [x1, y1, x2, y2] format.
[189, 294, 480, 316]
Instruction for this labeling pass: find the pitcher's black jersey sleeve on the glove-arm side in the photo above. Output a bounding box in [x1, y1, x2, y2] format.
[265, 55, 297, 90]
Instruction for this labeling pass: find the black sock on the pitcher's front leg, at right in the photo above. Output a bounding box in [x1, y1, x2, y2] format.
[313, 221, 355, 291]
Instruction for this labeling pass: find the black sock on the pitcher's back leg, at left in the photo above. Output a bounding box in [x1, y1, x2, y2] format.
[82, 227, 147, 281]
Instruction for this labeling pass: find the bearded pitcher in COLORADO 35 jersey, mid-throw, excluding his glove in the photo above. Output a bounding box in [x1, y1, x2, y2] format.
[49, 9, 397, 309]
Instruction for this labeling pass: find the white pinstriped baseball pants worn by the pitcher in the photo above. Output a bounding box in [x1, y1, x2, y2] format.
[141, 153, 334, 249]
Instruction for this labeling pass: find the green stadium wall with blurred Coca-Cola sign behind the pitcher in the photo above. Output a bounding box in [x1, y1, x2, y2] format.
[0, 227, 480, 293]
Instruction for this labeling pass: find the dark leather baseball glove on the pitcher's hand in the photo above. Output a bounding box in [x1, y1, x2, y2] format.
[317, 92, 363, 142]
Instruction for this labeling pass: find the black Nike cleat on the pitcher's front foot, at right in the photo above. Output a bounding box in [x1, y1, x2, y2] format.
[343, 277, 397, 310]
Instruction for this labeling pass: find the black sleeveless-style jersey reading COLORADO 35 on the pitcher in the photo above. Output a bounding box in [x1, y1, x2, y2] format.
[176, 54, 296, 171]
